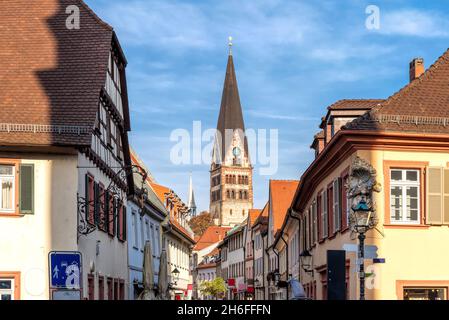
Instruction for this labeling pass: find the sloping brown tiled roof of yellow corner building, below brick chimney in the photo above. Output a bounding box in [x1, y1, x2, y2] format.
[343, 50, 449, 133]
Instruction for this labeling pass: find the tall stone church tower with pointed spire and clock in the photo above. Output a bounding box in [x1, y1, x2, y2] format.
[209, 37, 253, 226]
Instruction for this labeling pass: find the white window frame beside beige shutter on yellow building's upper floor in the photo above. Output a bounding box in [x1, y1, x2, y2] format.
[388, 168, 421, 225]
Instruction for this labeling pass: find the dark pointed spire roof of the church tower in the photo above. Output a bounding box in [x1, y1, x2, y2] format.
[217, 53, 248, 160]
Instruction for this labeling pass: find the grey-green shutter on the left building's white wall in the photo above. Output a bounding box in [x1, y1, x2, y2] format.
[19, 164, 34, 214]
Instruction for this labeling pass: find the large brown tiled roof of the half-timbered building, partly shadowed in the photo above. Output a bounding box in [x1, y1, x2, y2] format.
[0, 0, 114, 146]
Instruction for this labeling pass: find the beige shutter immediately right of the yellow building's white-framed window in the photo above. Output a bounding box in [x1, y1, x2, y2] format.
[426, 167, 443, 225]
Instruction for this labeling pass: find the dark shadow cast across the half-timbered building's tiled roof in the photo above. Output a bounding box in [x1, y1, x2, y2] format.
[37, 0, 112, 145]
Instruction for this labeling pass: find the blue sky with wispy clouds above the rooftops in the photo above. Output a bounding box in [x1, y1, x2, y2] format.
[86, 0, 449, 210]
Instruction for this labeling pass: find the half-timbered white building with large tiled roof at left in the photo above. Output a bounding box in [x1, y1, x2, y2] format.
[0, 0, 133, 299]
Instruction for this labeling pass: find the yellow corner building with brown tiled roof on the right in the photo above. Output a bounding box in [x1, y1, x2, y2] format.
[290, 52, 449, 300]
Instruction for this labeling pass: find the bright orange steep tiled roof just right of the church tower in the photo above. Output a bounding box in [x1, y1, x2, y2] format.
[269, 180, 299, 234]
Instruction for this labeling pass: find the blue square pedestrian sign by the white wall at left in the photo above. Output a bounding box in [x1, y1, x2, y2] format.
[48, 251, 82, 289]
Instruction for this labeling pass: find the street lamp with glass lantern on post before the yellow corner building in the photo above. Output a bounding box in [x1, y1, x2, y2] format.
[353, 200, 372, 300]
